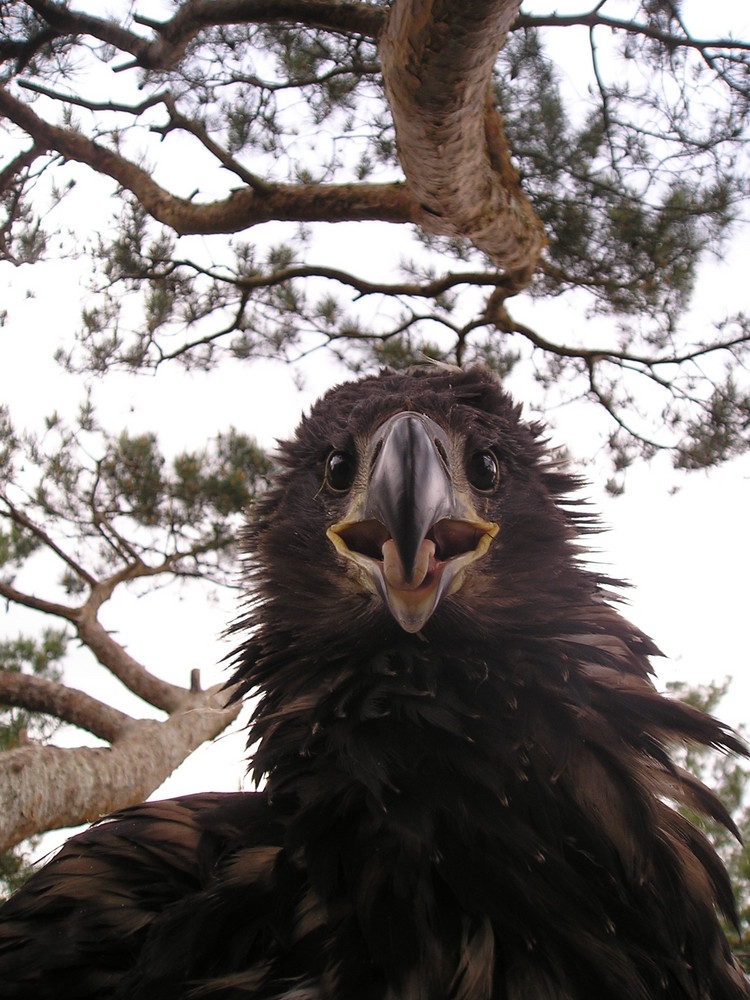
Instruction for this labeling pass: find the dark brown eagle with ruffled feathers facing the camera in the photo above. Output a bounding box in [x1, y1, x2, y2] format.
[0, 366, 750, 1000]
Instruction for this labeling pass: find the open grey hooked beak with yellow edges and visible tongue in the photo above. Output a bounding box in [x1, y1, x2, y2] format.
[328, 412, 499, 632]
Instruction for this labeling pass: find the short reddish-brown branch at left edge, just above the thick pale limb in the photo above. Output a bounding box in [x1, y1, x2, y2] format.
[0, 670, 133, 743]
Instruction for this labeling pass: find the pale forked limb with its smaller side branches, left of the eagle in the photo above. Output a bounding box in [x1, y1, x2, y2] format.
[0, 564, 241, 853]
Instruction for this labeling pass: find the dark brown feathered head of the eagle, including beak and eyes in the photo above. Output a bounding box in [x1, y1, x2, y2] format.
[251, 366, 591, 641]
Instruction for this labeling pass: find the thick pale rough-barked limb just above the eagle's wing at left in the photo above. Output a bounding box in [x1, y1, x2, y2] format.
[0, 688, 240, 852]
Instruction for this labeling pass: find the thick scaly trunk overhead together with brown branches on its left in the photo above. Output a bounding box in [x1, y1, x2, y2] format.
[0, 0, 544, 274]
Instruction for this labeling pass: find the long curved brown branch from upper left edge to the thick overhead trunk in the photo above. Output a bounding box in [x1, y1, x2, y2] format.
[0, 87, 422, 236]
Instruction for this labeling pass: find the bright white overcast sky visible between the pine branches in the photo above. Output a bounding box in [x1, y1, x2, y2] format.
[0, 0, 750, 852]
